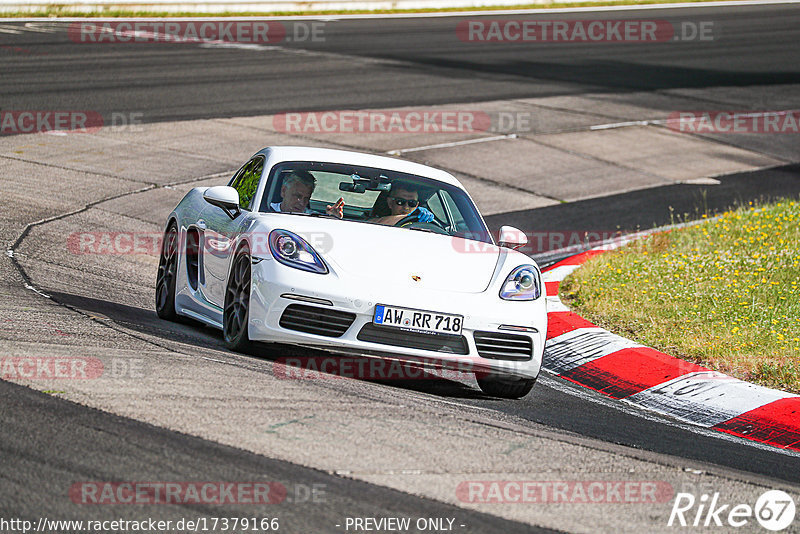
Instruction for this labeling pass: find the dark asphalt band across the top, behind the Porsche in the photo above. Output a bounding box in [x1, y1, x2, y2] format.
[0, 5, 800, 126]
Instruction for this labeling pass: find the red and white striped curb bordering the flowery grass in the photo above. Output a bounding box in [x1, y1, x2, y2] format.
[542, 250, 800, 451]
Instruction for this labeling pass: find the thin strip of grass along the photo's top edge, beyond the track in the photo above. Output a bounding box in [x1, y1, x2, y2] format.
[0, 0, 744, 18]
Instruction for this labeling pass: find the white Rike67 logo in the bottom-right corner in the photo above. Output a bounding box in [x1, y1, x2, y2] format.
[667, 490, 796, 532]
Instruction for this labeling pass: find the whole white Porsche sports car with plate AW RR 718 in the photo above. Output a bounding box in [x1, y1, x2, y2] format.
[156, 147, 547, 398]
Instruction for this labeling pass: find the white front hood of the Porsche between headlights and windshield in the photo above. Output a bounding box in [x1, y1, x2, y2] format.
[260, 215, 500, 293]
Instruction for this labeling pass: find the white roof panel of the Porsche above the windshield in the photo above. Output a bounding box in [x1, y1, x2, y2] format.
[253, 146, 464, 189]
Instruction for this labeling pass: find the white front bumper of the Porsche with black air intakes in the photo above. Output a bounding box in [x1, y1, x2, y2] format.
[249, 261, 547, 378]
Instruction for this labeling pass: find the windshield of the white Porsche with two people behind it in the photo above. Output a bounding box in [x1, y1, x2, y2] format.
[260, 161, 493, 243]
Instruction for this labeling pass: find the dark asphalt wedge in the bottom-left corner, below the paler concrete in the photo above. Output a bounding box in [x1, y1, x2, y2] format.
[0, 381, 552, 533]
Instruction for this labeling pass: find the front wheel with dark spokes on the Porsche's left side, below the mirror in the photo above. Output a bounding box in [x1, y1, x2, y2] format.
[222, 247, 252, 352]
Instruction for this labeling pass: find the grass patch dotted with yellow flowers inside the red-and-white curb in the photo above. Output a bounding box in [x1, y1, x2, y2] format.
[560, 200, 800, 393]
